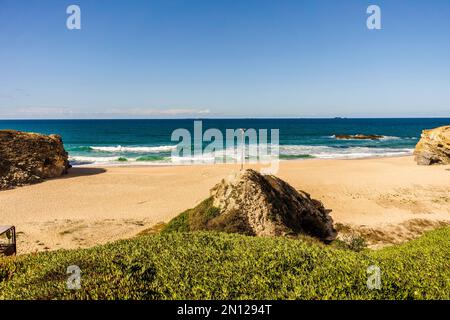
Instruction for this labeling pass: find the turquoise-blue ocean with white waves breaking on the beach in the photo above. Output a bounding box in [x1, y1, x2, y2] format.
[0, 118, 450, 166]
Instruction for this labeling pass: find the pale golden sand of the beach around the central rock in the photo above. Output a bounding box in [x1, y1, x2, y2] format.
[0, 157, 450, 254]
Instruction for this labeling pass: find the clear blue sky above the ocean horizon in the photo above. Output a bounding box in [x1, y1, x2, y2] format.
[0, 0, 450, 118]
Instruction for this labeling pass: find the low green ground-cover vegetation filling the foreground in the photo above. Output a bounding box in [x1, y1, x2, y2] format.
[0, 226, 450, 299]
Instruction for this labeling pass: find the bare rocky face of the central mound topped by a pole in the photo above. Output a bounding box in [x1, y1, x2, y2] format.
[209, 170, 337, 241]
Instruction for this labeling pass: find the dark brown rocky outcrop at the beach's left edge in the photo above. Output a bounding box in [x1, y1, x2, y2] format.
[0, 130, 70, 190]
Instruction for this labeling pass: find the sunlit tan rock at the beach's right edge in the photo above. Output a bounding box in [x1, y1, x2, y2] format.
[414, 125, 450, 165]
